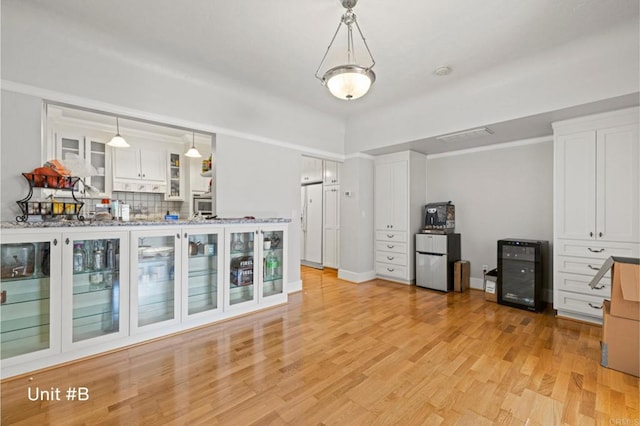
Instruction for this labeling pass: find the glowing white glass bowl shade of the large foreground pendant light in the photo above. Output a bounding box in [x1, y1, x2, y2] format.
[324, 65, 376, 100]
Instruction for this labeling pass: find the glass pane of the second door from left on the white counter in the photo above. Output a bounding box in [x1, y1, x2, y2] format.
[72, 239, 120, 342]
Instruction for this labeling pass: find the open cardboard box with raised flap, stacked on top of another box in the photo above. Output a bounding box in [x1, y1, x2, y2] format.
[589, 257, 640, 321]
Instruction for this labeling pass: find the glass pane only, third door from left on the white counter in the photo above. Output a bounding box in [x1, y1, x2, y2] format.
[138, 236, 175, 327]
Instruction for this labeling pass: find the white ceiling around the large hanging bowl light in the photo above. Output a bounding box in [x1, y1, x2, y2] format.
[17, 0, 639, 153]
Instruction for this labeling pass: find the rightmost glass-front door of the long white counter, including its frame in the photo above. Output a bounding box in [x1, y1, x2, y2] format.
[260, 229, 287, 298]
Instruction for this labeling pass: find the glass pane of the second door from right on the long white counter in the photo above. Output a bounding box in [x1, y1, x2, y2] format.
[229, 232, 254, 305]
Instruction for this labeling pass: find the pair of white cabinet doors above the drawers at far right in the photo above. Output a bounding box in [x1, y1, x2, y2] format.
[555, 113, 640, 242]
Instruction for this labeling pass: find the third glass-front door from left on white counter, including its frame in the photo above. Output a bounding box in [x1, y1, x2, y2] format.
[130, 230, 181, 334]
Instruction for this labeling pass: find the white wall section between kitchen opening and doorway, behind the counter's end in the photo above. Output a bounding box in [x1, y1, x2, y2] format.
[215, 134, 302, 282]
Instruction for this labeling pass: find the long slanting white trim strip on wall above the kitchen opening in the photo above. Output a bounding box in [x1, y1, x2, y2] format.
[0, 79, 344, 161]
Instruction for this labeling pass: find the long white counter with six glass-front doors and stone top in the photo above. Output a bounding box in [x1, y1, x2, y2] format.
[0, 218, 290, 378]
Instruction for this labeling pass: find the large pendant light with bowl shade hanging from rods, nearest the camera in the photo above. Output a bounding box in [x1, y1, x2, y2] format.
[316, 0, 376, 100]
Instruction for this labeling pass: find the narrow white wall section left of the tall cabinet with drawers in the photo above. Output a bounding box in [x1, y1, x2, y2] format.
[338, 156, 375, 282]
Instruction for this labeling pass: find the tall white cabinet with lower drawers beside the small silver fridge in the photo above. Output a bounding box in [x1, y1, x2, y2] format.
[374, 151, 427, 284]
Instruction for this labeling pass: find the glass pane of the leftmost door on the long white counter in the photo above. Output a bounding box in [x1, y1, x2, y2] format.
[0, 242, 51, 359]
